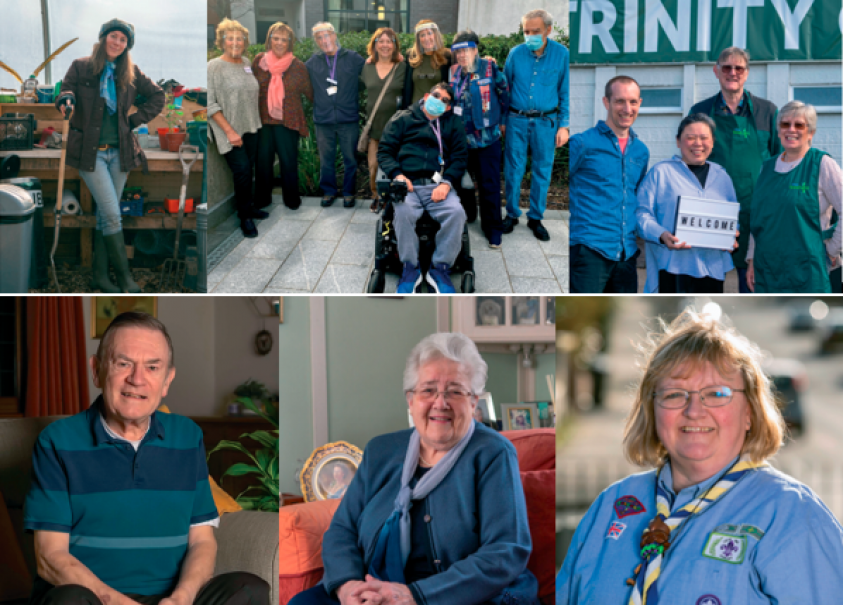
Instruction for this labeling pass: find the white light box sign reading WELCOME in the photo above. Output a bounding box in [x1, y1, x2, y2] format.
[673, 195, 741, 251]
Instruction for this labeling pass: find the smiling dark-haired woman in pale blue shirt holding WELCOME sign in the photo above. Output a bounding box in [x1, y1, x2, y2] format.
[636, 114, 738, 294]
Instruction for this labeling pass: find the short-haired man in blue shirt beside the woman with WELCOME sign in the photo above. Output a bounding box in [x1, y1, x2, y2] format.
[570, 76, 650, 294]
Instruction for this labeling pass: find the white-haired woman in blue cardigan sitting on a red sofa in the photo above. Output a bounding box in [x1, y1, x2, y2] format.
[290, 333, 538, 605]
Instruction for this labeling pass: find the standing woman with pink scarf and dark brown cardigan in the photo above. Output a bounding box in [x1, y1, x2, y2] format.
[252, 22, 313, 210]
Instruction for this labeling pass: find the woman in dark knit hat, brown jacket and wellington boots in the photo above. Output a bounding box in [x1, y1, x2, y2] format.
[56, 19, 164, 293]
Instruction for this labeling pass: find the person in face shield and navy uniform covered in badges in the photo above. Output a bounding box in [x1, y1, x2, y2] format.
[449, 31, 509, 248]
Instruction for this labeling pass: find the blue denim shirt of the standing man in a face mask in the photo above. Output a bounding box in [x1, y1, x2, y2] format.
[503, 38, 569, 128]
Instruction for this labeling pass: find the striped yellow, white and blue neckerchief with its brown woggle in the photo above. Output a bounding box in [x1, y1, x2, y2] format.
[629, 454, 767, 605]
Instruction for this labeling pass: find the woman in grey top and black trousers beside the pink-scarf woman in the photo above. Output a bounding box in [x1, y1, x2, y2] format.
[208, 19, 269, 237]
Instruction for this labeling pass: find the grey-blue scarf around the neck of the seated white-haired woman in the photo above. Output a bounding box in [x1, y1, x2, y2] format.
[369, 422, 475, 584]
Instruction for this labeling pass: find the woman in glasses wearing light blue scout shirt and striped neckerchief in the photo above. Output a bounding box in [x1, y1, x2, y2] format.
[556, 310, 843, 605]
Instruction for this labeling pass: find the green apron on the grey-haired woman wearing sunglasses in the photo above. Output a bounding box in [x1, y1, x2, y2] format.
[751, 149, 831, 294]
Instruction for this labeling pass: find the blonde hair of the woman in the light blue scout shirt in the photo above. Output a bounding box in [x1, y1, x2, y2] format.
[623, 308, 785, 467]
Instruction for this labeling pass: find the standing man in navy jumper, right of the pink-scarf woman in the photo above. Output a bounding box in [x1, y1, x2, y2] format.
[305, 23, 365, 208]
